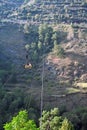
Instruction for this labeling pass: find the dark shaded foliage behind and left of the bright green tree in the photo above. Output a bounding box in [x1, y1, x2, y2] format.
[0, 86, 39, 130]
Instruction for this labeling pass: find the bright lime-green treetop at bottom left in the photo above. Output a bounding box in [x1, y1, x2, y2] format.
[4, 110, 39, 130]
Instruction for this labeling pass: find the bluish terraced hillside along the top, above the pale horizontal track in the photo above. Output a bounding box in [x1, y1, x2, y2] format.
[8, 0, 87, 24]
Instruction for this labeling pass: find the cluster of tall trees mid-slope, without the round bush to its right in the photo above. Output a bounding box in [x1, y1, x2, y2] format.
[24, 24, 53, 65]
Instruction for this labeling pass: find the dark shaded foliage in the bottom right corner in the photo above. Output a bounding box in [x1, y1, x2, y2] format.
[65, 107, 87, 130]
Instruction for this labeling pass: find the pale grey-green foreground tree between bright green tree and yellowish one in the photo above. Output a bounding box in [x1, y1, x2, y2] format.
[40, 108, 62, 130]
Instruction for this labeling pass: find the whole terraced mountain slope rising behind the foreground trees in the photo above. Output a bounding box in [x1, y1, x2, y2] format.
[0, 0, 87, 130]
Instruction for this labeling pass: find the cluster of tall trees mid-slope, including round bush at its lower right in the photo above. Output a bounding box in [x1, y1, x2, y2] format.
[24, 24, 66, 65]
